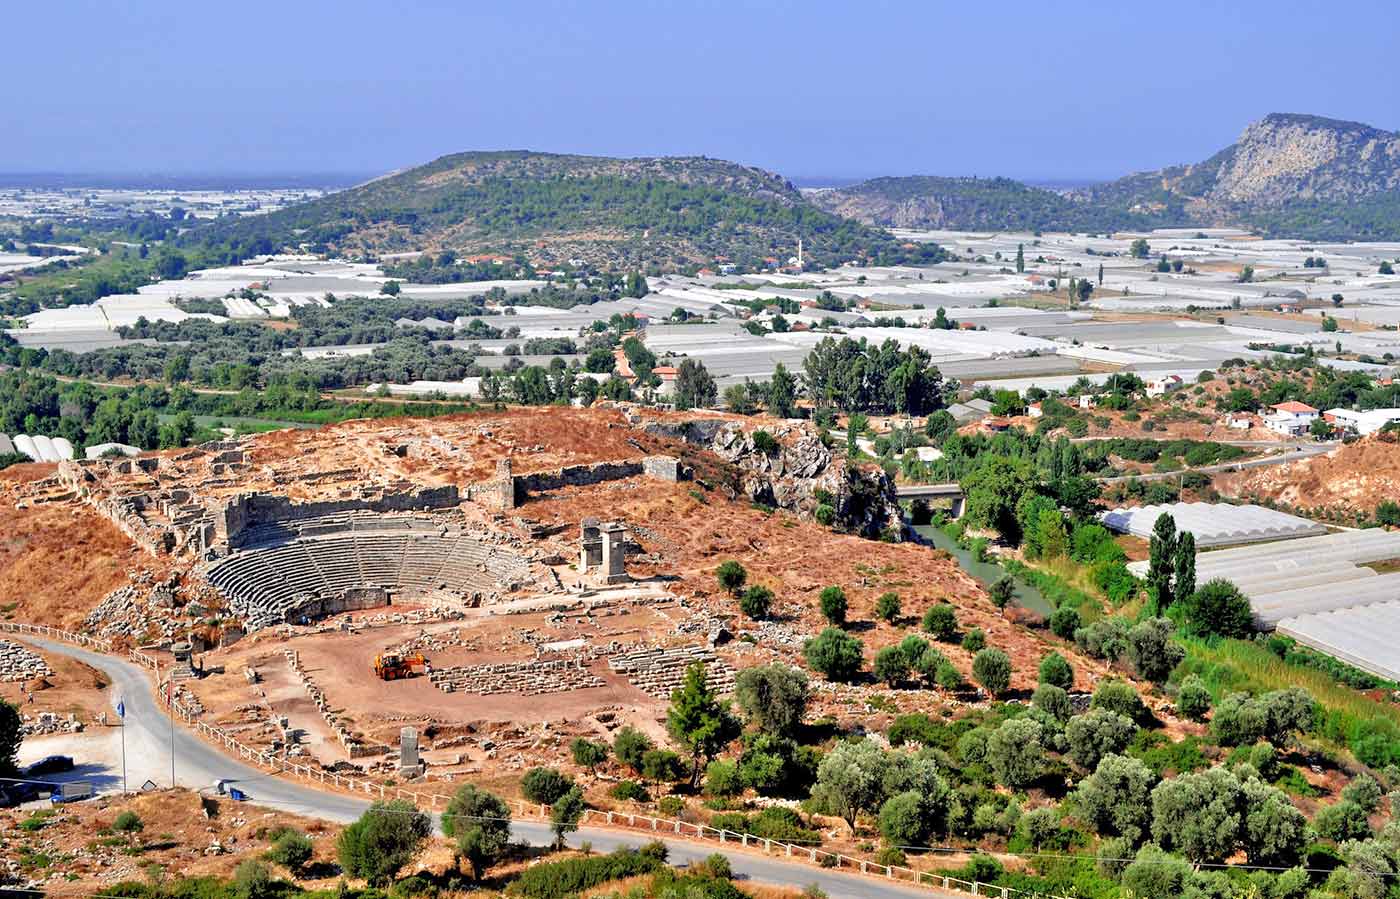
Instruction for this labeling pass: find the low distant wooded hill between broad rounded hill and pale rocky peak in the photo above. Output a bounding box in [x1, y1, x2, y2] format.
[808, 175, 1173, 231]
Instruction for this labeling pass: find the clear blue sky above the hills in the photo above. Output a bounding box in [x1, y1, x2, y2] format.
[0, 0, 1400, 179]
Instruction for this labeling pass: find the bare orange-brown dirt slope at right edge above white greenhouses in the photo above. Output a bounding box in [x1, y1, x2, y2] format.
[1217, 434, 1400, 515]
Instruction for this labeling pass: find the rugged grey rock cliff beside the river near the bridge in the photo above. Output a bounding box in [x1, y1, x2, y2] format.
[641, 419, 903, 539]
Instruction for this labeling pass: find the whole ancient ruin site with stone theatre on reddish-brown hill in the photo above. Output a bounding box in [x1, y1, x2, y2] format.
[3, 406, 1102, 800]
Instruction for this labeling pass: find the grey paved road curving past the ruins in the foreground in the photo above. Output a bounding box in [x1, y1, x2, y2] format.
[27, 636, 966, 899]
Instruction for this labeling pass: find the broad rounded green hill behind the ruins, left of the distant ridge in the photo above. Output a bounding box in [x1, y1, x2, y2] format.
[182, 151, 938, 267]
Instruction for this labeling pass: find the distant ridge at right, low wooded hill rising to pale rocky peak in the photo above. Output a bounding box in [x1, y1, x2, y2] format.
[811, 113, 1400, 239]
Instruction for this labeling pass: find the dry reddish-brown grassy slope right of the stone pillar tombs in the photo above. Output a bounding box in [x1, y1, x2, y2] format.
[518, 480, 1114, 690]
